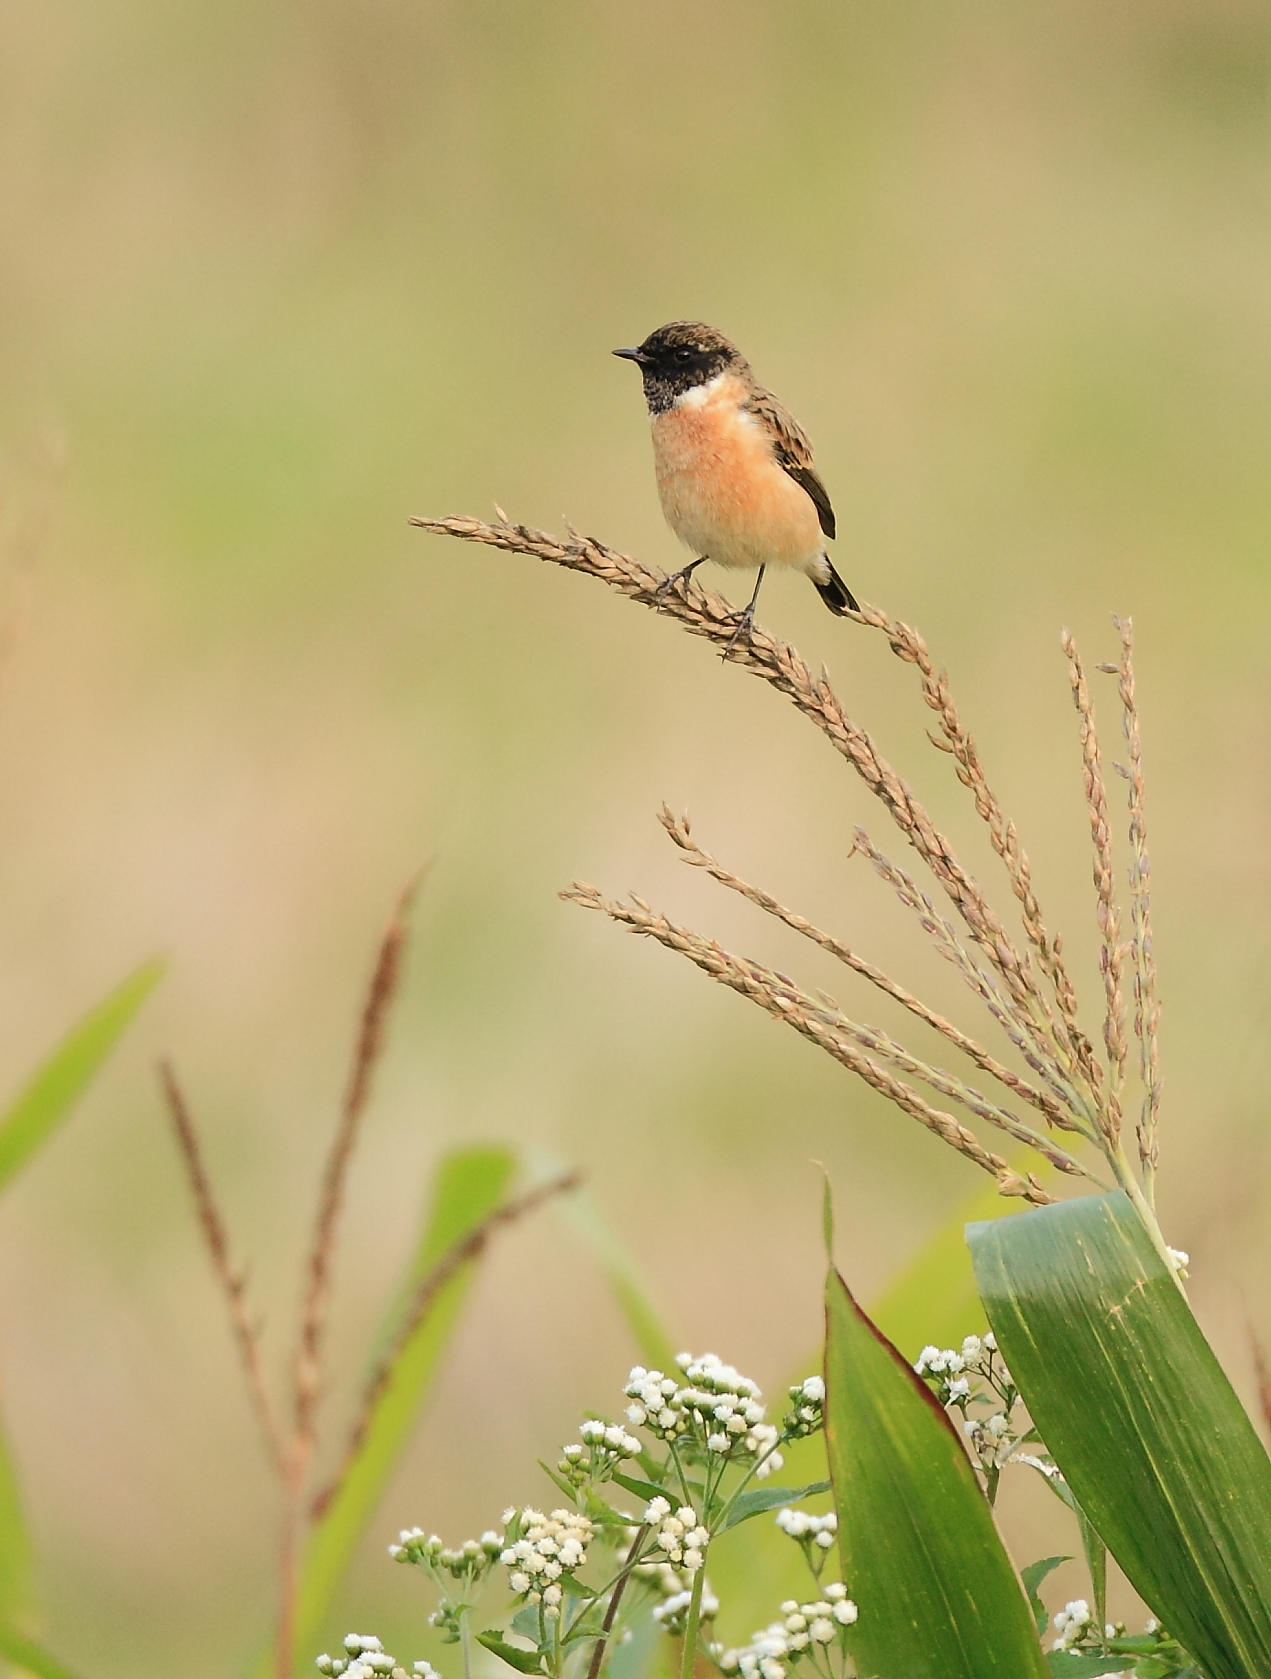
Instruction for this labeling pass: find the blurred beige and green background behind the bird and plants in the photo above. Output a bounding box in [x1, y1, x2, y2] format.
[0, 0, 1271, 1679]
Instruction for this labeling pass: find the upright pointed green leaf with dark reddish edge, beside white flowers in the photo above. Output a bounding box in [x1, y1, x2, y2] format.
[824, 1271, 1046, 1679]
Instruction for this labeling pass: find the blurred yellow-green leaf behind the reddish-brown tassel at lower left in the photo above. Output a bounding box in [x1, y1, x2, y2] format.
[280, 1148, 517, 1676]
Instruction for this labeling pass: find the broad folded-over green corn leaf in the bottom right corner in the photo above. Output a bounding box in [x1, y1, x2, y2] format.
[967, 1190, 1271, 1679]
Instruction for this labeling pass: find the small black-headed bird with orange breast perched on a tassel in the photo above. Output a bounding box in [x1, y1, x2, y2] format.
[613, 321, 860, 658]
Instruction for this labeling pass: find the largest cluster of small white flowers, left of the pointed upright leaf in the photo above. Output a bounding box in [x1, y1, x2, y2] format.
[623, 1353, 782, 1479]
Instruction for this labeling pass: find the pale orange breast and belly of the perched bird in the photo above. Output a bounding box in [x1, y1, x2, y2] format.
[653, 391, 824, 576]
